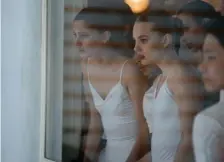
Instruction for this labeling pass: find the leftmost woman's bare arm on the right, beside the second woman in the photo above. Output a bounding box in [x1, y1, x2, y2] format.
[123, 61, 150, 162]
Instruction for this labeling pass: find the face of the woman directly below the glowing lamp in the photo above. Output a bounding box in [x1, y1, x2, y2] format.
[133, 22, 162, 66]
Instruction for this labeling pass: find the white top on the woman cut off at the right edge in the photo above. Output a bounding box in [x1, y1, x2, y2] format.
[193, 92, 224, 162]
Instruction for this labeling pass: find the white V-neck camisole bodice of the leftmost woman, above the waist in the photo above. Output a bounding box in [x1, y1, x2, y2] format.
[87, 60, 137, 140]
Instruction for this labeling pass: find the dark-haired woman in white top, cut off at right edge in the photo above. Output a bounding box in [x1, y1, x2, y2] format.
[193, 16, 224, 162]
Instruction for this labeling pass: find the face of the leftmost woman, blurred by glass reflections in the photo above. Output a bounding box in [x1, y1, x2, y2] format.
[73, 20, 102, 58]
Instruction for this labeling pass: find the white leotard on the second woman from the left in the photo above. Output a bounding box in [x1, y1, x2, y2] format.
[148, 76, 181, 162]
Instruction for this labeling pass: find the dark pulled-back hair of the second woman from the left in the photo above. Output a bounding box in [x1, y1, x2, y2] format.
[136, 10, 183, 54]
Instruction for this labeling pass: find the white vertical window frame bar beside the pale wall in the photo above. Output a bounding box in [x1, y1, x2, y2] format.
[39, 0, 88, 162]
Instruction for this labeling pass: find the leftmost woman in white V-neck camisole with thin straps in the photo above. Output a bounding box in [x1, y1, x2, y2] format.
[73, 8, 147, 162]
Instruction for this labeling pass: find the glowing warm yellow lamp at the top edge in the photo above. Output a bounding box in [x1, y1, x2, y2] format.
[125, 0, 149, 13]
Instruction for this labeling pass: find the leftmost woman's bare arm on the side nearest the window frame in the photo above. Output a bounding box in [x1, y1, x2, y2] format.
[82, 63, 102, 162]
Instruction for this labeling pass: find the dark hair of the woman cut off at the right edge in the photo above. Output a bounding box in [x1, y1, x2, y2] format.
[205, 13, 224, 48]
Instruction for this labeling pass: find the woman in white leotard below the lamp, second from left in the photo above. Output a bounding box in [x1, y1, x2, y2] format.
[130, 11, 202, 162]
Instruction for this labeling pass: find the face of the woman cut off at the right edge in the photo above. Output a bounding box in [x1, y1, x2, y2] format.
[199, 34, 224, 92]
